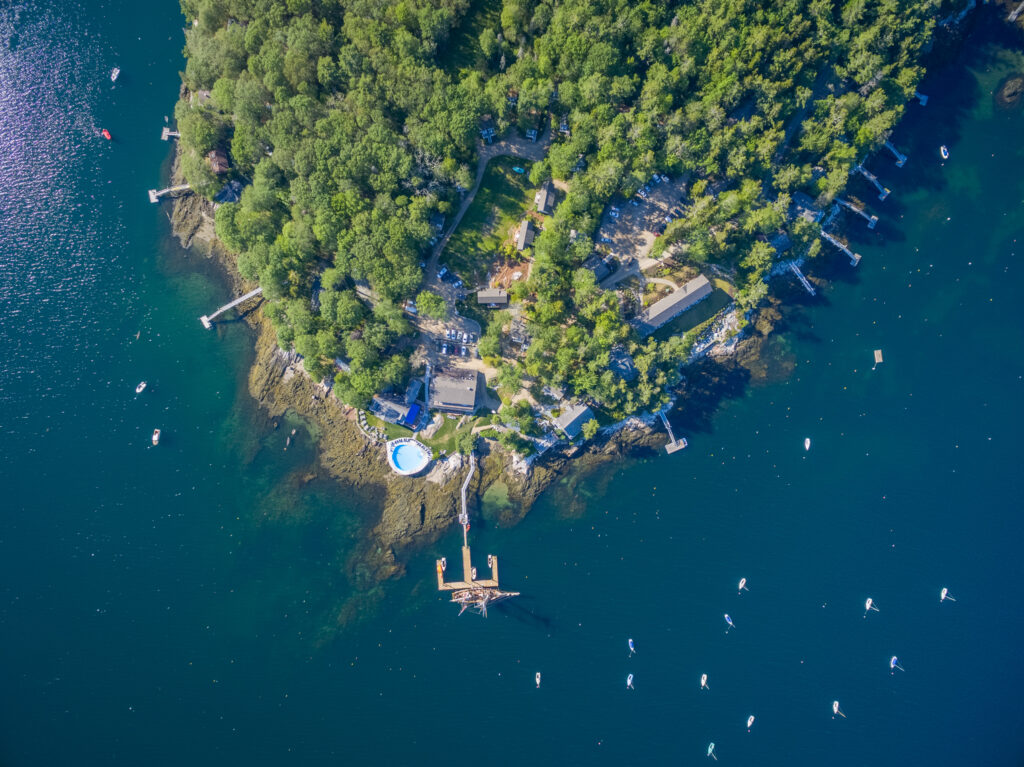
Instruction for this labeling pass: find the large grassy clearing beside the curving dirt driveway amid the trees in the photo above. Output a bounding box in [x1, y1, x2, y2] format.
[441, 157, 535, 287]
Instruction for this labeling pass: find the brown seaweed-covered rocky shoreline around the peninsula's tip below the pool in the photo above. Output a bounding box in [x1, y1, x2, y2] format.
[165, 152, 679, 592]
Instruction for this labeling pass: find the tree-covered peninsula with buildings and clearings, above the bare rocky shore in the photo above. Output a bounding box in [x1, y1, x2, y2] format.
[175, 0, 958, 456]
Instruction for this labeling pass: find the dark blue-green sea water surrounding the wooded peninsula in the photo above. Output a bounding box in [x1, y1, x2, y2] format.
[0, 0, 1024, 766]
